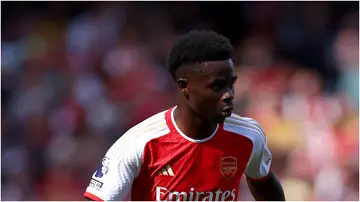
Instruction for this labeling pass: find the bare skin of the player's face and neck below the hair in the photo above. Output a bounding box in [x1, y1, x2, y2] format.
[174, 60, 237, 139]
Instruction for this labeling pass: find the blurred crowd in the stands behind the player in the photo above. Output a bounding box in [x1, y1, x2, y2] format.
[1, 2, 359, 200]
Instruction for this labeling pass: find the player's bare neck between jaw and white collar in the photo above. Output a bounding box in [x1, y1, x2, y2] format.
[174, 105, 217, 140]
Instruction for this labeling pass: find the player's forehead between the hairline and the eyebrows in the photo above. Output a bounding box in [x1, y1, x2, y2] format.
[195, 59, 236, 77]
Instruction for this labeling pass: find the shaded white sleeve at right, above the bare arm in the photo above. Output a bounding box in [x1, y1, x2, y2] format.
[244, 134, 272, 180]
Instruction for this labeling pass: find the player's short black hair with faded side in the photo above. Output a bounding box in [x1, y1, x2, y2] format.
[167, 30, 233, 80]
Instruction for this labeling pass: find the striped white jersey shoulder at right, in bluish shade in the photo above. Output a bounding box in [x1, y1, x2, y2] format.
[224, 113, 266, 144]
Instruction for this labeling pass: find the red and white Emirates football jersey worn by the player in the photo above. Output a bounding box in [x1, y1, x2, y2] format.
[84, 107, 271, 201]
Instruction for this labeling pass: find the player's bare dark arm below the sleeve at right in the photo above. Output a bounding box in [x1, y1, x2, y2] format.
[246, 172, 285, 201]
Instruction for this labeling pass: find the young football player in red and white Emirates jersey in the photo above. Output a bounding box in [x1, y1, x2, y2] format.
[84, 31, 285, 201]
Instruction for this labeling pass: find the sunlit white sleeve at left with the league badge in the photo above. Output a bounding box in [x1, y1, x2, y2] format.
[84, 137, 142, 201]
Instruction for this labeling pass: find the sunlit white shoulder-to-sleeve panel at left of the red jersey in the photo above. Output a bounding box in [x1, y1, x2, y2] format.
[86, 111, 170, 201]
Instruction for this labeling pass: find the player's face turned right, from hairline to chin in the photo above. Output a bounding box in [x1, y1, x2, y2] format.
[181, 59, 237, 123]
